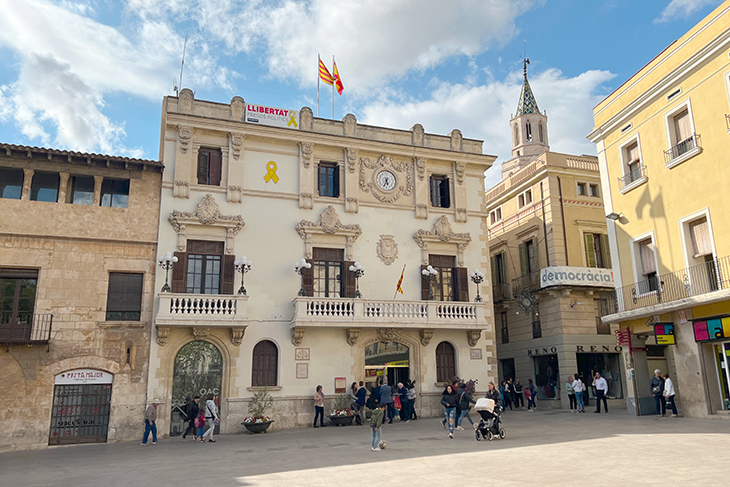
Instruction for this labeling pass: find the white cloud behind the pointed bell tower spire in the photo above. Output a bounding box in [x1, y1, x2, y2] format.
[361, 69, 615, 187]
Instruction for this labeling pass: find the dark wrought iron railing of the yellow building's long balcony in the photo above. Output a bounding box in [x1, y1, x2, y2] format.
[615, 256, 730, 313]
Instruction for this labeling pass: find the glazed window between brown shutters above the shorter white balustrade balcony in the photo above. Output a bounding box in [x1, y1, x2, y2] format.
[185, 240, 223, 294]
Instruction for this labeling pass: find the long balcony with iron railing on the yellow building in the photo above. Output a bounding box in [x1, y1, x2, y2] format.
[603, 256, 730, 323]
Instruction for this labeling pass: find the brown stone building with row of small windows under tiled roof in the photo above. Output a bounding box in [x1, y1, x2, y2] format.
[0, 144, 162, 450]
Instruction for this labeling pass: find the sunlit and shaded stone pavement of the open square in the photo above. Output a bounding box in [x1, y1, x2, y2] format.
[0, 409, 730, 487]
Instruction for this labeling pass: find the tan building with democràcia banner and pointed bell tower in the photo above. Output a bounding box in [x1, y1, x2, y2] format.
[486, 62, 624, 408]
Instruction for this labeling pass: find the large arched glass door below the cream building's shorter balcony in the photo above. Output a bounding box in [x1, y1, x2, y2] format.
[170, 340, 223, 436]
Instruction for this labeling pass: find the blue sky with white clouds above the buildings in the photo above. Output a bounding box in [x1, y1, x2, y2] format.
[0, 0, 722, 187]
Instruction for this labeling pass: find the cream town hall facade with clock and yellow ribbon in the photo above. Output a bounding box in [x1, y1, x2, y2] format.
[148, 89, 496, 435]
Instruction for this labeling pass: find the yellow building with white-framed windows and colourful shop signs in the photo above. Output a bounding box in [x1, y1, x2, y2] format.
[588, 2, 730, 417]
